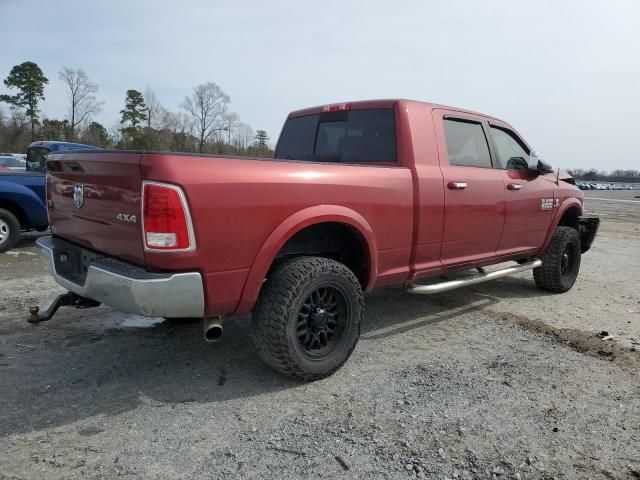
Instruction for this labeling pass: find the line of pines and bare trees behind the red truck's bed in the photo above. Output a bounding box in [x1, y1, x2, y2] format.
[0, 62, 273, 156]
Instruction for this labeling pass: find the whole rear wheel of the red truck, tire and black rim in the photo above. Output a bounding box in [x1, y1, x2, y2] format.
[252, 257, 364, 381]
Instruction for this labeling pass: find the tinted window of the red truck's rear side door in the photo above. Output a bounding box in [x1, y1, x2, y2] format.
[444, 119, 491, 168]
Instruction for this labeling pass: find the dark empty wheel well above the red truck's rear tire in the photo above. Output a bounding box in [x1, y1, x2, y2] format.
[267, 222, 370, 290]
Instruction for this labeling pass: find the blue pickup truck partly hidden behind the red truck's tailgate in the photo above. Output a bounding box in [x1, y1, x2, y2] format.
[0, 141, 100, 252]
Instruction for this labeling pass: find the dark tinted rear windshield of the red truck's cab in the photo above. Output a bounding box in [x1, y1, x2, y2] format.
[275, 108, 396, 163]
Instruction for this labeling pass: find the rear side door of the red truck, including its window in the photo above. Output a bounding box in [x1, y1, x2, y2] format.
[434, 110, 506, 266]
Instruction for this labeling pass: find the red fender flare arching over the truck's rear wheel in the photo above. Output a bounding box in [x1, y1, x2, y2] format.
[235, 205, 378, 314]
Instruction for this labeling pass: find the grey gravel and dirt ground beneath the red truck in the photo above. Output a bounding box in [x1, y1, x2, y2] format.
[0, 191, 640, 479]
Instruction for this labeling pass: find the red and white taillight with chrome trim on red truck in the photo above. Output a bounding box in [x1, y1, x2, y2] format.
[142, 182, 196, 252]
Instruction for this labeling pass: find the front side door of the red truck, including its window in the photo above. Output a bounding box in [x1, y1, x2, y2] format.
[489, 123, 555, 254]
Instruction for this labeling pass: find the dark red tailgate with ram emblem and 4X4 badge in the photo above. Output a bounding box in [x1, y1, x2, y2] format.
[47, 152, 144, 265]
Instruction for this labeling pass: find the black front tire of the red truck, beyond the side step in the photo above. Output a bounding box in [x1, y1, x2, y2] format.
[533, 227, 581, 293]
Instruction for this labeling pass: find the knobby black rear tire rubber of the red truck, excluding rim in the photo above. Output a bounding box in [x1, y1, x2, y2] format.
[252, 257, 364, 381]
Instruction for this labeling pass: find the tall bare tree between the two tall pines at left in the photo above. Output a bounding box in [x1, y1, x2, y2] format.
[58, 67, 104, 141]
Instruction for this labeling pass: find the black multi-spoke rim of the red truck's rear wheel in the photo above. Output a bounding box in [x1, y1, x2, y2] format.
[296, 285, 349, 358]
